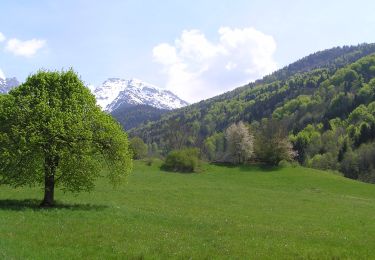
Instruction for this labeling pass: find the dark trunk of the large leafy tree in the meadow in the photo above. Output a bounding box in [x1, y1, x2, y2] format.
[40, 156, 57, 208]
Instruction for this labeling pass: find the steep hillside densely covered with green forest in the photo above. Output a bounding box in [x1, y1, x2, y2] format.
[130, 44, 375, 182]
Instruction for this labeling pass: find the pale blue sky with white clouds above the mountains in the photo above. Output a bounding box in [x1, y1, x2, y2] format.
[0, 0, 375, 102]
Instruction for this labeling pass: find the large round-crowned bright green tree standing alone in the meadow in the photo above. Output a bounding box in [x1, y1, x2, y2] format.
[0, 70, 132, 207]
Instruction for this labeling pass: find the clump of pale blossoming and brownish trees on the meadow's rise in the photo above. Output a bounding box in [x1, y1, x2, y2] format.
[204, 119, 296, 166]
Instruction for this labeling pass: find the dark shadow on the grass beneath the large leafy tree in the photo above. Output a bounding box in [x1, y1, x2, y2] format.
[0, 199, 108, 211]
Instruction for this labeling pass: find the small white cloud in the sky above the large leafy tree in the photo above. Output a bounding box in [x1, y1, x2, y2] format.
[5, 38, 46, 58]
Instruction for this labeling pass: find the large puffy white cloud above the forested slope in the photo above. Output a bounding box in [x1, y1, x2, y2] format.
[153, 27, 277, 102]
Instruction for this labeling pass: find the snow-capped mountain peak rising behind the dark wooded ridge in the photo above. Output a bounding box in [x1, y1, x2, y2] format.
[93, 78, 188, 112]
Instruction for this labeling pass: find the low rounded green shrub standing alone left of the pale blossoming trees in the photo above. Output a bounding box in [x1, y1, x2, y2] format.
[162, 148, 199, 172]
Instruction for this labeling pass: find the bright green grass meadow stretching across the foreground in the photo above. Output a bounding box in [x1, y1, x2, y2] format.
[0, 162, 375, 259]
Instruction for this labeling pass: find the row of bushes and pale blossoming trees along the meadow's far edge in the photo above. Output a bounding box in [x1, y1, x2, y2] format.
[130, 119, 297, 172]
